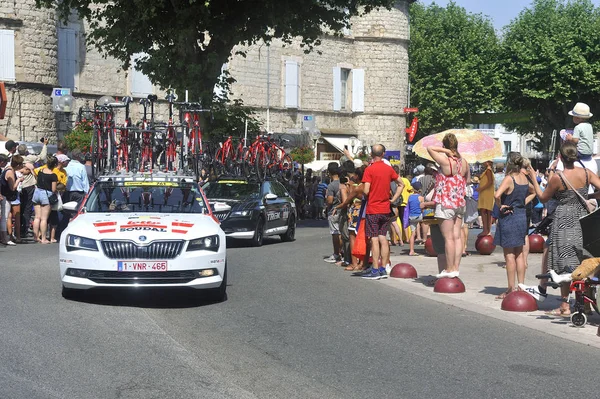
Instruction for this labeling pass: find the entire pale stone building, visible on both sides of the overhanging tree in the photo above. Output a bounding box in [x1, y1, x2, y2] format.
[0, 0, 411, 164]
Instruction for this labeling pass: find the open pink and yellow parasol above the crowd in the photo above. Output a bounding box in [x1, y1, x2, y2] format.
[413, 129, 502, 163]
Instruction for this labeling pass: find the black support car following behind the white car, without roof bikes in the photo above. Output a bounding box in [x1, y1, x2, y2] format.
[202, 178, 297, 246]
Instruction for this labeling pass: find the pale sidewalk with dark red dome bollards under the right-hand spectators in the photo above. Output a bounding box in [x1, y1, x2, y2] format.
[381, 245, 600, 348]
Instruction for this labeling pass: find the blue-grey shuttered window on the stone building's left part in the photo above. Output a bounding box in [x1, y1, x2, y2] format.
[58, 28, 79, 91]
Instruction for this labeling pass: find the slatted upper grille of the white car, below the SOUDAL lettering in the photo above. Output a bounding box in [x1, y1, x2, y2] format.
[102, 241, 183, 260]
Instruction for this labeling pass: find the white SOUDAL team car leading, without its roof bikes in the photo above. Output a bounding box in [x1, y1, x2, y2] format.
[59, 174, 228, 301]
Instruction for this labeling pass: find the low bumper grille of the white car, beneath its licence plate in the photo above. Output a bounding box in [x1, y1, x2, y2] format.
[88, 270, 199, 284]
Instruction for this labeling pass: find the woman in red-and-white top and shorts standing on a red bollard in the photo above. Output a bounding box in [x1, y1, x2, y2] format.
[427, 133, 471, 278]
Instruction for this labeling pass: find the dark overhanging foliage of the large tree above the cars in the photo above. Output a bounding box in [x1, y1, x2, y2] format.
[36, 0, 394, 104]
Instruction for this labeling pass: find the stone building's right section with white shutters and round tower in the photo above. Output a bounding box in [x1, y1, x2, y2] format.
[227, 1, 412, 160]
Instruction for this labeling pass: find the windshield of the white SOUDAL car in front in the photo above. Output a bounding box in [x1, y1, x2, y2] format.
[85, 182, 208, 213]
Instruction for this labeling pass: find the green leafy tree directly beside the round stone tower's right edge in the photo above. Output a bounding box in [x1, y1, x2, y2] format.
[409, 2, 500, 133]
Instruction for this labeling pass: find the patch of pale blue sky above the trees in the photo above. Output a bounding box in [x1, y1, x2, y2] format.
[419, 0, 600, 31]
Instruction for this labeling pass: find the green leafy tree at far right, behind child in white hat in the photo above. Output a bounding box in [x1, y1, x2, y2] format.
[501, 0, 600, 149]
